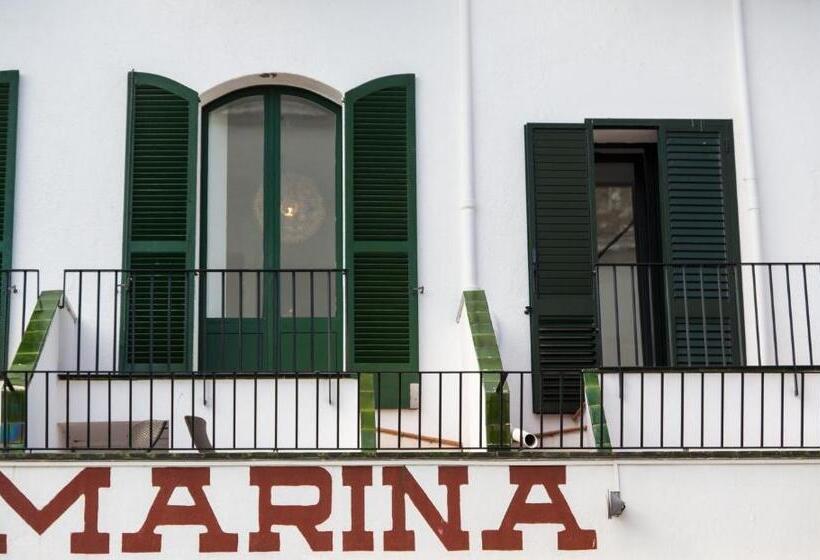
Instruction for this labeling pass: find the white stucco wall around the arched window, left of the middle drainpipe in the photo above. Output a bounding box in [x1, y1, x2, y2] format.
[0, 1, 460, 376]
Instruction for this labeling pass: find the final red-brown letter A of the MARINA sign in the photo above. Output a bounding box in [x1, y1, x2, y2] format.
[481, 466, 597, 550]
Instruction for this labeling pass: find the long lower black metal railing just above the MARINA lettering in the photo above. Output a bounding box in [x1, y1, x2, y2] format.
[0, 367, 820, 452]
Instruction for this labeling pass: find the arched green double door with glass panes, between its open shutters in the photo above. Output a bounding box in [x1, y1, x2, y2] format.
[200, 88, 342, 372]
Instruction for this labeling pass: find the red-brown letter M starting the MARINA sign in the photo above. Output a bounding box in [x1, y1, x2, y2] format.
[0, 467, 111, 554]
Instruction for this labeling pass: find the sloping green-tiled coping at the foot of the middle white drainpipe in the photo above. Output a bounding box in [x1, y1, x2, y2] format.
[464, 290, 512, 449]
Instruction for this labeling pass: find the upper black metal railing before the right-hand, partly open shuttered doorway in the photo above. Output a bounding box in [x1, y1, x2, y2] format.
[594, 263, 820, 368]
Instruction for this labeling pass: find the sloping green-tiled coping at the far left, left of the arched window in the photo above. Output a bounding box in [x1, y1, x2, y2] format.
[3, 290, 63, 436]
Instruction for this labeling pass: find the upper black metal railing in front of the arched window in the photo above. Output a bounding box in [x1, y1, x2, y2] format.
[63, 269, 346, 373]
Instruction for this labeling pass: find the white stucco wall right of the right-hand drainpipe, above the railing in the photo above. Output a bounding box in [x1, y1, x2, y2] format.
[747, 0, 820, 262]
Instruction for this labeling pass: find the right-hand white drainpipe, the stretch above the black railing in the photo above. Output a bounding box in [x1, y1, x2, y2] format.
[734, 0, 763, 262]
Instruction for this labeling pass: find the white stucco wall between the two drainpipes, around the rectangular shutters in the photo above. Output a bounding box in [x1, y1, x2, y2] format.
[474, 2, 742, 376]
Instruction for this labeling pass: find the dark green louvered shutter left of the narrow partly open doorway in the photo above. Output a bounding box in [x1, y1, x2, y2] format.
[525, 124, 598, 413]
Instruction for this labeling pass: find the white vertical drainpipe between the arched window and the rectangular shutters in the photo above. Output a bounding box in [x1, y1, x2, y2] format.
[457, 0, 478, 290]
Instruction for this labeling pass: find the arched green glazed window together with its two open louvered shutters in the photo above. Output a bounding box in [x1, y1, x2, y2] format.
[122, 72, 418, 408]
